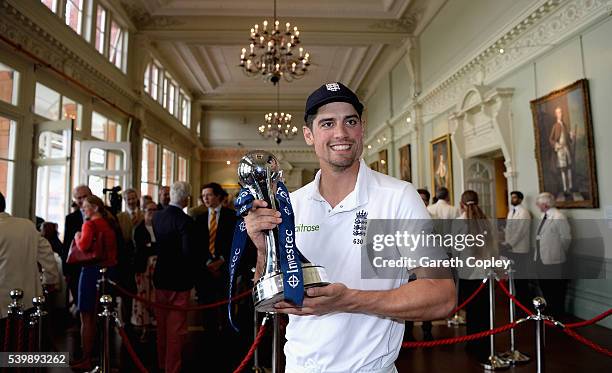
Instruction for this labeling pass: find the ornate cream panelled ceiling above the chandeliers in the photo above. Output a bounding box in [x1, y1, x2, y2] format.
[121, 0, 445, 111]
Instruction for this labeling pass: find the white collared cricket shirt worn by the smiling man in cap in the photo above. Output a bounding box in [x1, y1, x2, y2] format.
[285, 160, 429, 373]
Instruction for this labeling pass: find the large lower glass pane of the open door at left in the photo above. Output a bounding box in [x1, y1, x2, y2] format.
[36, 165, 67, 232]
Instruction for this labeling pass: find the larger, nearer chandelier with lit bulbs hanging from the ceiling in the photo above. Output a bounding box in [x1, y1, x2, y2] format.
[240, 0, 310, 84]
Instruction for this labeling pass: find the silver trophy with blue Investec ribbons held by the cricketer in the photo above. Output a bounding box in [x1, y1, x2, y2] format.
[238, 150, 329, 312]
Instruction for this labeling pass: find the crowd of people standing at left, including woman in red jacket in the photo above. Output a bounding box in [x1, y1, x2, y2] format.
[0, 182, 254, 372]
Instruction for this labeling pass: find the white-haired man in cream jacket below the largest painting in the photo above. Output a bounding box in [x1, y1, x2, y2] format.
[533, 192, 572, 317]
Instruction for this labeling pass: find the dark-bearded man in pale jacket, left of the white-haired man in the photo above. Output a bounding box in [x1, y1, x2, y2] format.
[501, 190, 531, 301]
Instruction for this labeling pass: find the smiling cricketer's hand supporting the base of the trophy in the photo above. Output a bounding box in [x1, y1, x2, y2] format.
[274, 283, 356, 316]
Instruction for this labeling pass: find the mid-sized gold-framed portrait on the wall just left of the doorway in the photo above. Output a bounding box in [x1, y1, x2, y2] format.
[429, 134, 453, 203]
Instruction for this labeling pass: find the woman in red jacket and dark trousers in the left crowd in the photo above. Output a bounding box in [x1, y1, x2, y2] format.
[72, 195, 118, 370]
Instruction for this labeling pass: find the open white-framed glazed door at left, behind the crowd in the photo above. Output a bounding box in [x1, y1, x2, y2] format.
[32, 119, 74, 232]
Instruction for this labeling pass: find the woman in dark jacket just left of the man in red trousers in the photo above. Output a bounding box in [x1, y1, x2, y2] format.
[132, 201, 157, 341]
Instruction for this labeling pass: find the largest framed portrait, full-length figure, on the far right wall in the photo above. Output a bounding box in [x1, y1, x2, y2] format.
[531, 79, 599, 208]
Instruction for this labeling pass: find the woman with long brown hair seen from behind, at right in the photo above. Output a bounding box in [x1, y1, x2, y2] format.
[453, 190, 498, 362]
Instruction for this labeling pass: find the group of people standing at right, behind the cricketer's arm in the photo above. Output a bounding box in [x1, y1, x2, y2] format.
[404, 187, 572, 362]
